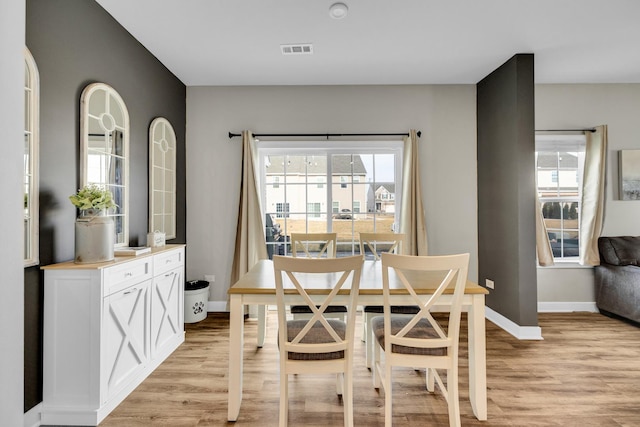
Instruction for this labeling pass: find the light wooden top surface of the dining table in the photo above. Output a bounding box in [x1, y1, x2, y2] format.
[228, 260, 489, 295]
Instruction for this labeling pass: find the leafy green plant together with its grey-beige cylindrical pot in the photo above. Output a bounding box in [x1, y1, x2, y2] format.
[69, 184, 117, 264]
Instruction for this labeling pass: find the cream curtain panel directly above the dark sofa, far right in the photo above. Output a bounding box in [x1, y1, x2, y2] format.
[580, 125, 607, 265]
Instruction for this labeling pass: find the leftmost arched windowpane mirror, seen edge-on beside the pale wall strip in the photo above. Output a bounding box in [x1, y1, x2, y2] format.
[23, 48, 40, 267]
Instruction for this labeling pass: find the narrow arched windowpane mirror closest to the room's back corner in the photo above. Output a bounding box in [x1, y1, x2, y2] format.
[149, 117, 176, 239]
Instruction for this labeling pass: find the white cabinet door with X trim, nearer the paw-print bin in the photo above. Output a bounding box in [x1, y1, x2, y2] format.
[151, 267, 184, 357]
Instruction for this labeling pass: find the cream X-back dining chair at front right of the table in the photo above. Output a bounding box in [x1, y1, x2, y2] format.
[371, 254, 469, 427]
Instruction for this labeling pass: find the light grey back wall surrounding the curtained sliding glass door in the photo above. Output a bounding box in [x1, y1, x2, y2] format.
[186, 85, 478, 308]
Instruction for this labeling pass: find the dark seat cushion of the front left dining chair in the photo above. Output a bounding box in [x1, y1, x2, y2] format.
[287, 319, 347, 360]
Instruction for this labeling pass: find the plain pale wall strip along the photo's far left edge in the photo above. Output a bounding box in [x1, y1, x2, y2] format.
[0, 0, 25, 426]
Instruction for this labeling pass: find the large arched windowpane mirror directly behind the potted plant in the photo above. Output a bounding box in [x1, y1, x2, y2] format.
[80, 83, 129, 246]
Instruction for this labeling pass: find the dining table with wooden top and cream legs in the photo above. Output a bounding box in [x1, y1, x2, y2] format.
[227, 259, 488, 421]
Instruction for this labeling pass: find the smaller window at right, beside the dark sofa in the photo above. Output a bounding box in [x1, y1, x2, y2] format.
[536, 135, 585, 261]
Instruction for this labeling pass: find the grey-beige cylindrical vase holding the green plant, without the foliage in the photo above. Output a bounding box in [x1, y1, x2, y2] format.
[74, 211, 115, 264]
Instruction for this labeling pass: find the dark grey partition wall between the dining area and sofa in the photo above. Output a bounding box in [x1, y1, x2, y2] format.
[477, 54, 538, 326]
